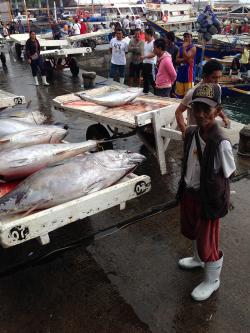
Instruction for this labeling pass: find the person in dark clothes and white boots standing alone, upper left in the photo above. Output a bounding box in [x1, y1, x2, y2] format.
[25, 31, 49, 86]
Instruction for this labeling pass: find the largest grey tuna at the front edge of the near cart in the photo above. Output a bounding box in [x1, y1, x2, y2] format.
[0, 150, 145, 215]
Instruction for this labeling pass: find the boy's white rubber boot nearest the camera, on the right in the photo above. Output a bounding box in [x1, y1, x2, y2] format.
[191, 254, 223, 301]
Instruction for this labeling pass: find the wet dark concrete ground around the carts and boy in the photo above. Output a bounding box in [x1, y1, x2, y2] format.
[0, 45, 250, 333]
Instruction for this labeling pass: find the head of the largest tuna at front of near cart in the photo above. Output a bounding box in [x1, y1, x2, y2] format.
[97, 150, 146, 170]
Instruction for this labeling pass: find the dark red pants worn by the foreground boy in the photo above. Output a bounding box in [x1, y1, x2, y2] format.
[180, 191, 220, 262]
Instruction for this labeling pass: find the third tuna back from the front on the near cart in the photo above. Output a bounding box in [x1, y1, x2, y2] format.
[0, 126, 67, 151]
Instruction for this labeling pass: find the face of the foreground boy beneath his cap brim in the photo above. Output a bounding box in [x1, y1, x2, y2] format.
[192, 102, 219, 129]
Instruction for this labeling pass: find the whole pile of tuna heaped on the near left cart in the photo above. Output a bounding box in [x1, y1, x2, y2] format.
[0, 110, 144, 216]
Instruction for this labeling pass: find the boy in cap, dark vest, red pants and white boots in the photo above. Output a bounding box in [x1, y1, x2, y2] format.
[177, 83, 236, 301]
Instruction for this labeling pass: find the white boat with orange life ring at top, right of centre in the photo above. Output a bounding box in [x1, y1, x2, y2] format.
[146, 3, 196, 34]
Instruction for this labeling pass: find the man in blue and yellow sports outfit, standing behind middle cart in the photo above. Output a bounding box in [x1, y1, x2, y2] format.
[175, 32, 196, 98]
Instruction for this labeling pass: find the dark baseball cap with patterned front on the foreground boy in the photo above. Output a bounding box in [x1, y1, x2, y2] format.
[191, 83, 221, 107]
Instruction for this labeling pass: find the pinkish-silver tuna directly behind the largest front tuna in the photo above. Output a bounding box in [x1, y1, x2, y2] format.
[0, 140, 97, 180]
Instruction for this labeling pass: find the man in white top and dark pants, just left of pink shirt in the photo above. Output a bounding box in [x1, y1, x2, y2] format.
[141, 29, 156, 94]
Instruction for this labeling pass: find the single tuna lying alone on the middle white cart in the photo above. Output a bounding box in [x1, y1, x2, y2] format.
[79, 88, 142, 107]
